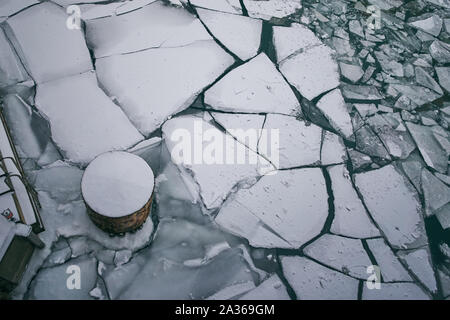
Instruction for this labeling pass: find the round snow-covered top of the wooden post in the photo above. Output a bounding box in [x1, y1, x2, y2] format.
[81, 151, 155, 218]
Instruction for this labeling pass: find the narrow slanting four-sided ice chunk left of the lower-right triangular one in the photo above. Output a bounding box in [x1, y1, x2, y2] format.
[367, 238, 413, 282]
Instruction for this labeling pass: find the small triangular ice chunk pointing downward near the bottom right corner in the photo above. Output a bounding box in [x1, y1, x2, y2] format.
[398, 248, 437, 293]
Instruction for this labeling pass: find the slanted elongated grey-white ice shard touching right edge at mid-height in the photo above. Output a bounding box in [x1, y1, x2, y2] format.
[406, 122, 448, 173]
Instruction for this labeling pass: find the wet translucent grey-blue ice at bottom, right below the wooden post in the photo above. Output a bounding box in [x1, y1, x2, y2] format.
[104, 219, 253, 299]
